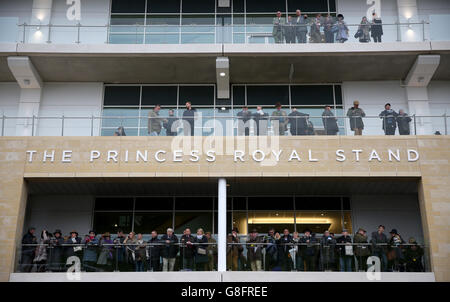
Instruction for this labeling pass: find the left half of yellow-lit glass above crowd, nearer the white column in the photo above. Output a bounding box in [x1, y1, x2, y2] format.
[248, 211, 294, 233]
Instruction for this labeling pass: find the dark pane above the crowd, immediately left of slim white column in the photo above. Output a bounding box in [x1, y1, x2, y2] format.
[175, 212, 213, 234]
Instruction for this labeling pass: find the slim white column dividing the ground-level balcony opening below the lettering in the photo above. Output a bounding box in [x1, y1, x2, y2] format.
[217, 178, 227, 272]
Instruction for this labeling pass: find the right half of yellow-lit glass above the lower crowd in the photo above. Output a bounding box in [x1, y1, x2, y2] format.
[295, 210, 342, 234]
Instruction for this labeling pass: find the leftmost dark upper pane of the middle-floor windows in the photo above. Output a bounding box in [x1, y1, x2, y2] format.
[104, 86, 141, 106]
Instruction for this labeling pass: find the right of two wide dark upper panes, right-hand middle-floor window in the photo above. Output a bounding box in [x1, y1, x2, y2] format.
[291, 85, 334, 105]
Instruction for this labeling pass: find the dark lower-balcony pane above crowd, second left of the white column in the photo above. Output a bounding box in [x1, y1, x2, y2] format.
[134, 213, 173, 234]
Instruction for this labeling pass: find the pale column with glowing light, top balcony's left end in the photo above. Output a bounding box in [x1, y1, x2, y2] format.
[27, 0, 53, 43]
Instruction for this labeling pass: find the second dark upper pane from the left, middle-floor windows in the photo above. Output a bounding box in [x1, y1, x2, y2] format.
[142, 86, 177, 106]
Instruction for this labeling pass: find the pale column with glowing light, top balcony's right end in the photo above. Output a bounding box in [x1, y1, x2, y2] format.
[397, 0, 423, 42]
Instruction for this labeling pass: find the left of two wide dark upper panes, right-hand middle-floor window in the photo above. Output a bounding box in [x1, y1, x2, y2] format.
[247, 85, 289, 106]
